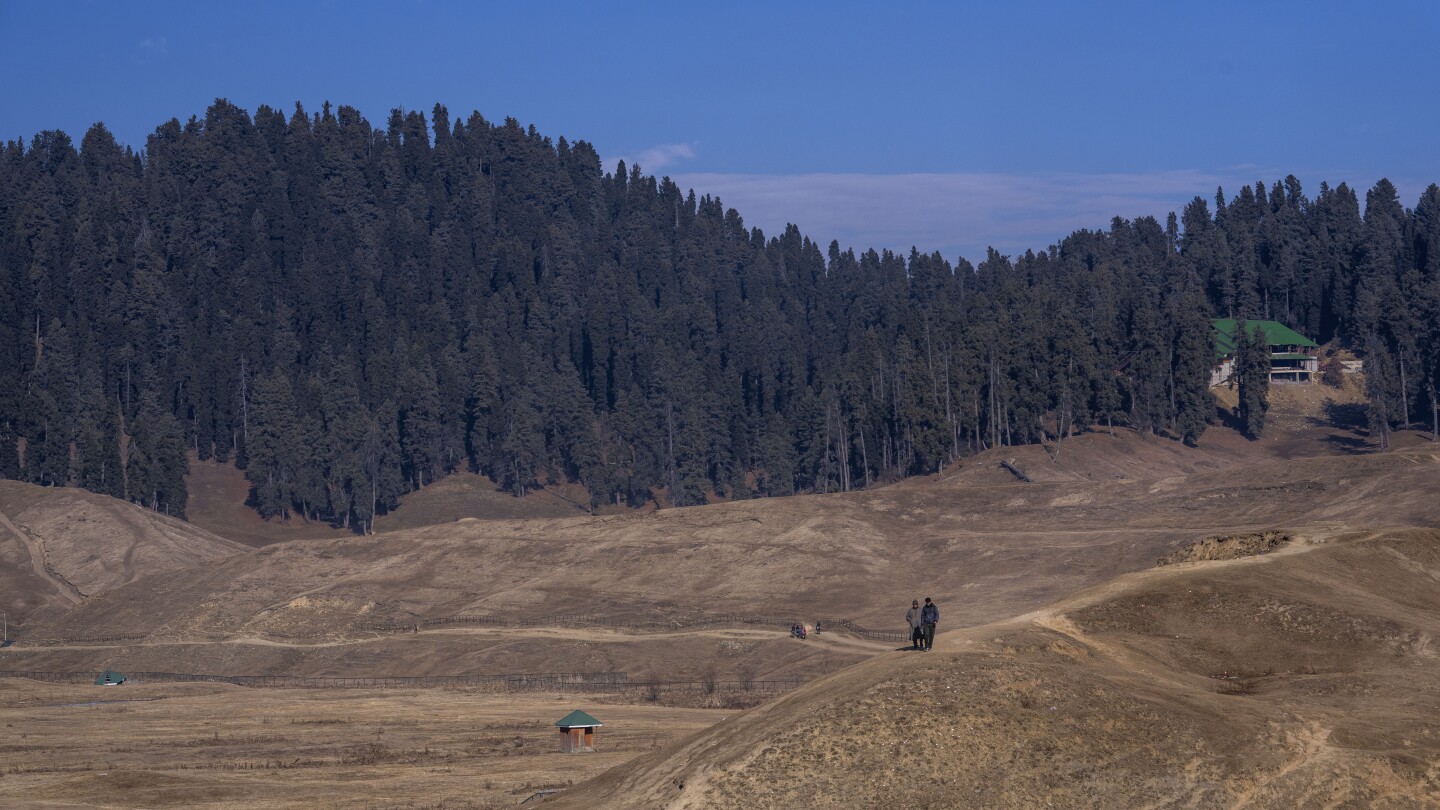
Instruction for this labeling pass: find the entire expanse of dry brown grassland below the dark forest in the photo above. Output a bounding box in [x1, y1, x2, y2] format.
[0, 386, 1440, 810]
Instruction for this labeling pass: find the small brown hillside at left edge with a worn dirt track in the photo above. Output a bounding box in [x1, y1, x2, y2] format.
[0, 481, 245, 623]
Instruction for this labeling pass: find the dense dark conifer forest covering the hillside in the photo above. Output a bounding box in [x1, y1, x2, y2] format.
[0, 101, 1440, 530]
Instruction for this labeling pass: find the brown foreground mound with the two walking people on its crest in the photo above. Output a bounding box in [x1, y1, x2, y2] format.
[549, 529, 1440, 810]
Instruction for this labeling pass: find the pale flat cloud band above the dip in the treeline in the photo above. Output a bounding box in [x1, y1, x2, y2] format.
[665, 164, 1423, 261]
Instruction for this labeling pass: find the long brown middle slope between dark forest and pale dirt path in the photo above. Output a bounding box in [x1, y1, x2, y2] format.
[22, 437, 1440, 660]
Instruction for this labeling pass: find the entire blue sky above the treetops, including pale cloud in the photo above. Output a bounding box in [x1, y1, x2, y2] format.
[0, 0, 1440, 261]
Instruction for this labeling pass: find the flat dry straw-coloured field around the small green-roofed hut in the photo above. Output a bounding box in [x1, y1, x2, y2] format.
[0, 679, 734, 809]
